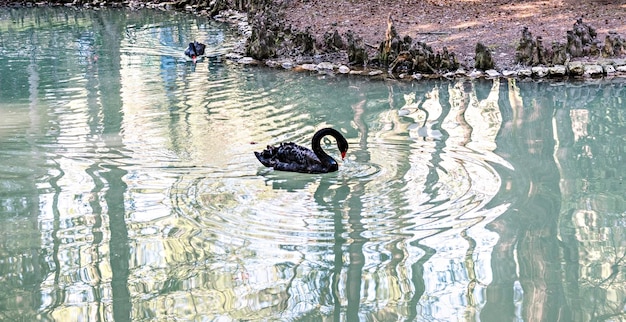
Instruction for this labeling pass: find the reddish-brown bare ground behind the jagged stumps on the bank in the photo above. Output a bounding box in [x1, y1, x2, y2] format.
[286, 0, 626, 68]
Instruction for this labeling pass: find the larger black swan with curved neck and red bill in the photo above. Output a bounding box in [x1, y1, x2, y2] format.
[254, 128, 348, 173]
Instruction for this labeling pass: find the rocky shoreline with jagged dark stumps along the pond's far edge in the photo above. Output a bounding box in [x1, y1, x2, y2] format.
[0, 0, 626, 80]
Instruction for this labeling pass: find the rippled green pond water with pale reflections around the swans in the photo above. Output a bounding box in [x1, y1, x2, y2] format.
[0, 8, 626, 321]
